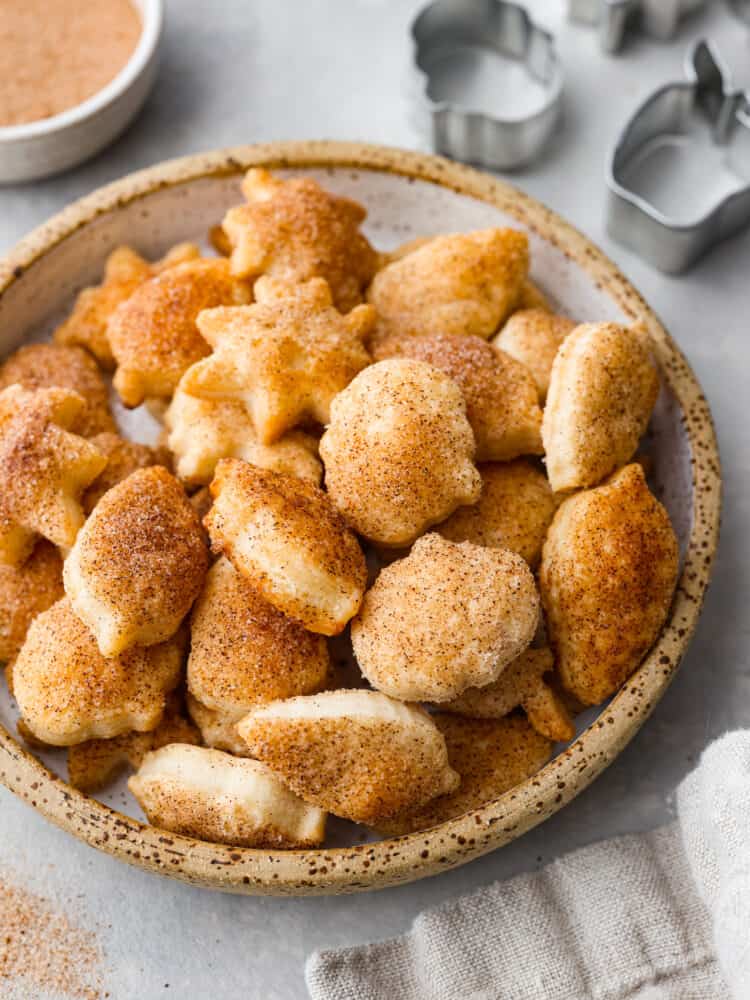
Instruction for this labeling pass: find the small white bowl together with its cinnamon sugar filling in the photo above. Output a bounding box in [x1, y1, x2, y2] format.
[0, 0, 164, 183]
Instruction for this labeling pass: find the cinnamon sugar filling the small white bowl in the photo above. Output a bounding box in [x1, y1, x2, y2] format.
[0, 0, 141, 126]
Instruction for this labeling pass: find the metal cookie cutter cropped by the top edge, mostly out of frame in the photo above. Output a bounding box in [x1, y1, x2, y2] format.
[568, 0, 706, 52]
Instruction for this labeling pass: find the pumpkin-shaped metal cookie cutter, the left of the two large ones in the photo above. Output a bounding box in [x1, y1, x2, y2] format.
[411, 0, 562, 170]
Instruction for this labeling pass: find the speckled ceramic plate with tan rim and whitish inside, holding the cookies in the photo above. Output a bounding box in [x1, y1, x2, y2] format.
[0, 142, 721, 895]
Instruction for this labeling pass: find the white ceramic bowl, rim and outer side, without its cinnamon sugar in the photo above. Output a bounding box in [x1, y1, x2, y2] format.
[0, 0, 164, 184]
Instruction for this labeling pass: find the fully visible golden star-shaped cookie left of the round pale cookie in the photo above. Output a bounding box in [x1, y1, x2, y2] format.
[181, 277, 375, 444]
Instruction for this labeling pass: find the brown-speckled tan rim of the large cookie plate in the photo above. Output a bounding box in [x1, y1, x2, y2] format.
[0, 140, 721, 895]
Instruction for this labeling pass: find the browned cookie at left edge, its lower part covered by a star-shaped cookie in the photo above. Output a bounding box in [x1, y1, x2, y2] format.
[0, 344, 116, 437]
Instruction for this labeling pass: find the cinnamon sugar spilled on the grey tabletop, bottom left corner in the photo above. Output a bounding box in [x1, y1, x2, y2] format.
[0, 876, 108, 1000]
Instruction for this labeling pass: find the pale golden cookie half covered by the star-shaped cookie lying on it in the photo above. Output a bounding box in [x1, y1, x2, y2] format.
[165, 384, 323, 486]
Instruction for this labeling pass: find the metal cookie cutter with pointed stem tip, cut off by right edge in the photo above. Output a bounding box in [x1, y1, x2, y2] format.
[607, 41, 750, 274]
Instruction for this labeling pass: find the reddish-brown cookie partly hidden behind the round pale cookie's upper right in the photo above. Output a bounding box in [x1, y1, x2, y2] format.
[373, 333, 543, 462]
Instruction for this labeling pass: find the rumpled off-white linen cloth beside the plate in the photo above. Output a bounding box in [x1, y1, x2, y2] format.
[306, 732, 750, 1000]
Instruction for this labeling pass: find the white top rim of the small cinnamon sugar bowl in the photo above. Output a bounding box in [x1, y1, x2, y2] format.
[0, 0, 164, 144]
